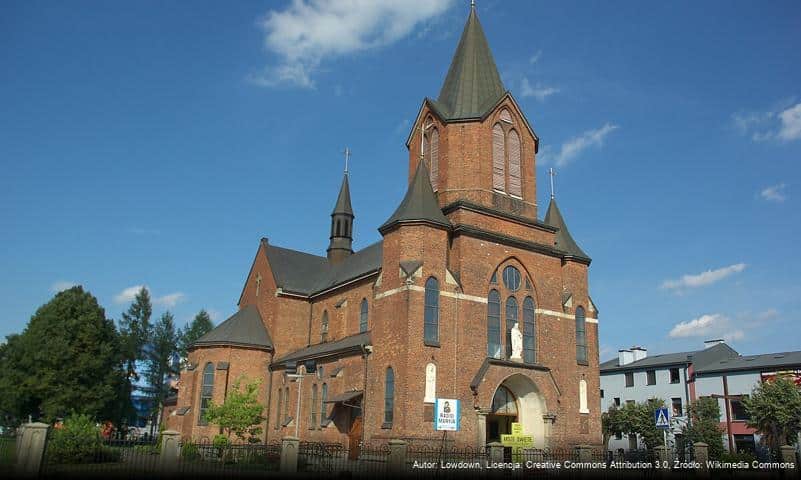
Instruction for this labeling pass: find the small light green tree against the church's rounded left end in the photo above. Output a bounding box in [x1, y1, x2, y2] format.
[206, 377, 264, 442]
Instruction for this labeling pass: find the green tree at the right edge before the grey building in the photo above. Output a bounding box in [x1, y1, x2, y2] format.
[743, 377, 801, 452]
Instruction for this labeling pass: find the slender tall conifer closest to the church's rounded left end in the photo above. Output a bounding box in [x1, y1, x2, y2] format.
[145, 311, 178, 435]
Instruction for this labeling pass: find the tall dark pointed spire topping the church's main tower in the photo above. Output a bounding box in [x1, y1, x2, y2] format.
[436, 3, 506, 120]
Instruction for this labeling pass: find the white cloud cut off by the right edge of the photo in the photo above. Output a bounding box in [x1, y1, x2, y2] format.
[732, 99, 801, 142]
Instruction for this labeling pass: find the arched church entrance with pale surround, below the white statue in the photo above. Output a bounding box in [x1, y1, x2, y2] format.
[483, 373, 546, 448]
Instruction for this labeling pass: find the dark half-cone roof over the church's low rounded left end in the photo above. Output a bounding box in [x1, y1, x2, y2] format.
[191, 305, 273, 350]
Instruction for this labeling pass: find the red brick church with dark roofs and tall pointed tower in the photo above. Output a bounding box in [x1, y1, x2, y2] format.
[167, 7, 601, 451]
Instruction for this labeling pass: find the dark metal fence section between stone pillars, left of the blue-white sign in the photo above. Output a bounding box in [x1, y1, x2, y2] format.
[298, 442, 390, 475]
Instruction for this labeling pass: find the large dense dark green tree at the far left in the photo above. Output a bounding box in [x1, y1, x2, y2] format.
[0, 287, 130, 421]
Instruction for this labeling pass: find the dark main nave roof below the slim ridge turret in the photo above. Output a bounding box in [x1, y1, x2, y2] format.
[265, 241, 383, 296]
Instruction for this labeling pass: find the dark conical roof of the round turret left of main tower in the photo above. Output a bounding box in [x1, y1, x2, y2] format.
[378, 162, 451, 234]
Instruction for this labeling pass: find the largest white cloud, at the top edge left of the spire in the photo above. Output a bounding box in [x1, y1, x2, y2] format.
[248, 0, 453, 88]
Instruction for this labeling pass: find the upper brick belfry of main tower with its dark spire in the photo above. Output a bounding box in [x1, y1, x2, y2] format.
[406, 6, 539, 221]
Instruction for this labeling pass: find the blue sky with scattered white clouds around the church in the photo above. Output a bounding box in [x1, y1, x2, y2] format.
[0, 0, 801, 359]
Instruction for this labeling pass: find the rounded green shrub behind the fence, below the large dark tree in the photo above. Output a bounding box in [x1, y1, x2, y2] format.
[47, 415, 103, 463]
